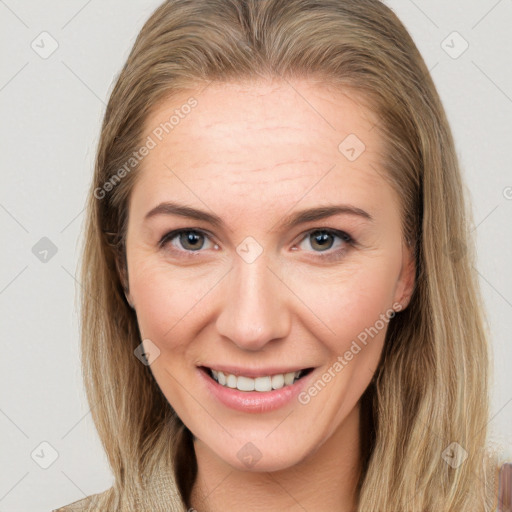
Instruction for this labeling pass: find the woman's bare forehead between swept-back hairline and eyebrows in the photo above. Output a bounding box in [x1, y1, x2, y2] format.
[134, 81, 388, 218]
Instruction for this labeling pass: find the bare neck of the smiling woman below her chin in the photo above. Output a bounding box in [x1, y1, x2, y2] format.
[189, 403, 361, 512]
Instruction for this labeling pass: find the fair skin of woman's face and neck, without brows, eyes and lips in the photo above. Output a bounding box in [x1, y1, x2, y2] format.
[126, 80, 414, 512]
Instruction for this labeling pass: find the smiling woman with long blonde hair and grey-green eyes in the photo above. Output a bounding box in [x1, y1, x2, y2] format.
[55, 0, 508, 512]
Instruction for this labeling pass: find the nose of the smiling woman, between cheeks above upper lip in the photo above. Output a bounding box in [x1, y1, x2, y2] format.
[216, 253, 291, 351]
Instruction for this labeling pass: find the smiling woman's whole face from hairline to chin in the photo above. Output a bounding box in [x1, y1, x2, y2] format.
[126, 81, 414, 471]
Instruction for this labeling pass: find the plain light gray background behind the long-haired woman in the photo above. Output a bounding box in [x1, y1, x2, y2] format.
[0, 0, 512, 512]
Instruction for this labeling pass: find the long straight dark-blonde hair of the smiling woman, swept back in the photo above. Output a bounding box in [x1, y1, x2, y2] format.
[80, 0, 497, 512]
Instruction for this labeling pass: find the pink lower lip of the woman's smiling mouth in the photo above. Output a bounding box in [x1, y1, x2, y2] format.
[198, 368, 314, 413]
